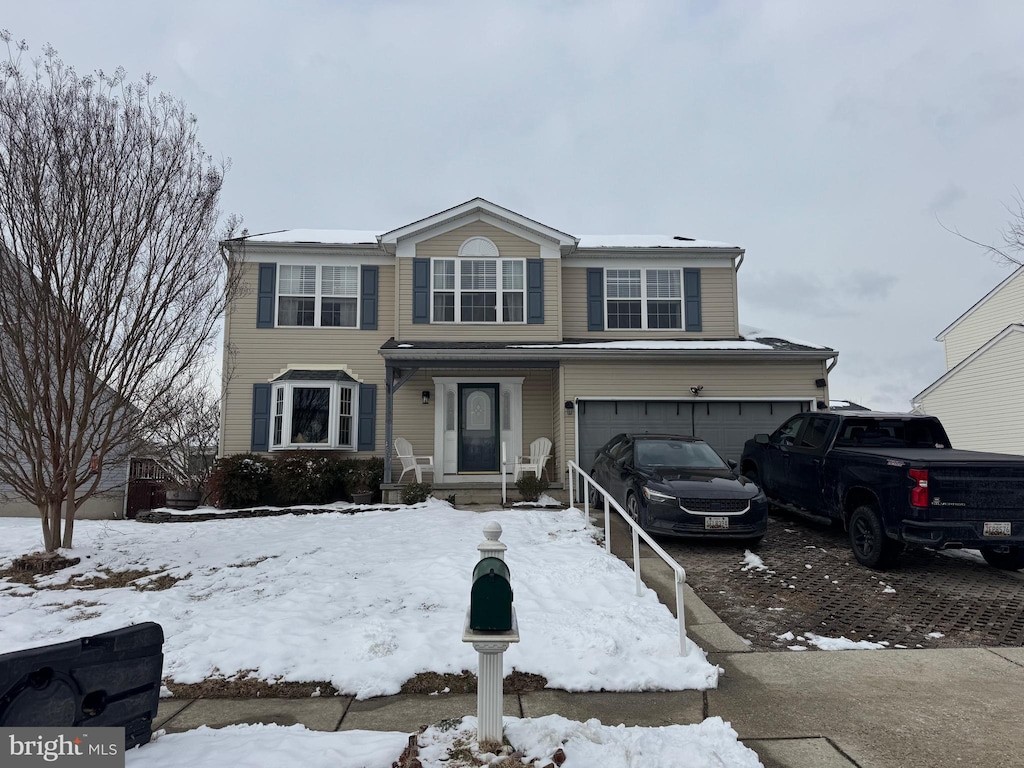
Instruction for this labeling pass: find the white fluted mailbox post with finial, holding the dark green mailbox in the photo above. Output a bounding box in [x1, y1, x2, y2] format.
[462, 522, 519, 743]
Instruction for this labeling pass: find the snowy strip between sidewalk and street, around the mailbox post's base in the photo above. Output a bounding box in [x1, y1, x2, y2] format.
[126, 715, 761, 768]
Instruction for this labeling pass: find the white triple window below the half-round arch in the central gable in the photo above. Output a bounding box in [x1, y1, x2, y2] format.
[431, 258, 526, 323]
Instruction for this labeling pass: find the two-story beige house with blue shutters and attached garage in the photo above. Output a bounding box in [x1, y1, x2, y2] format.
[220, 199, 837, 499]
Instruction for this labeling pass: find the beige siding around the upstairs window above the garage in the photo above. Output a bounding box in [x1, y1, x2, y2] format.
[561, 264, 739, 339]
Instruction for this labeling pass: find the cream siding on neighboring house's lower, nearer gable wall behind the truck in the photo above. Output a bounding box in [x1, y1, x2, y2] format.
[918, 332, 1024, 455]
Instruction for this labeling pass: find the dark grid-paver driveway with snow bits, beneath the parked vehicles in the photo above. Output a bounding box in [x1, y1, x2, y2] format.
[659, 511, 1024, 650]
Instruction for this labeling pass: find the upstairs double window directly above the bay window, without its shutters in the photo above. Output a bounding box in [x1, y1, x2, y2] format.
[278, 264, 359, 328]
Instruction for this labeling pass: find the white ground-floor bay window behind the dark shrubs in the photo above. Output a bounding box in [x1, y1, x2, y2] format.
[270, 381, 358, 451]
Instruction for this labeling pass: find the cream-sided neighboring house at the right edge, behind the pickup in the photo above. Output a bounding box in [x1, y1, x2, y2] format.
[912, 268, 1024, 455]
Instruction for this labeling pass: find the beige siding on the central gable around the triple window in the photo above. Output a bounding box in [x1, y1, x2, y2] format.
[395, 221, 561, 341]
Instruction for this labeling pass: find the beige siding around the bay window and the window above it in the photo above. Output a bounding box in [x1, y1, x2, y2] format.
[220, 257, 394, 456]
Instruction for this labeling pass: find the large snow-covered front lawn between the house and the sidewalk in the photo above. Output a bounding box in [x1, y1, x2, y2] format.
[0, 500, 719, 698]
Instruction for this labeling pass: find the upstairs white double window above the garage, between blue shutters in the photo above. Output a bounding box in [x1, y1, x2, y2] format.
[605, 269, 683, 330]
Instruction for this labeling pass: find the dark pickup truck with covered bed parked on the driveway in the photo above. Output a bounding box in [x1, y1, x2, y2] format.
[740, 411, 1024, 570]
